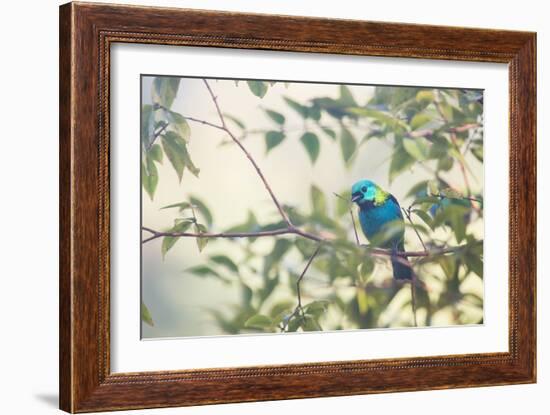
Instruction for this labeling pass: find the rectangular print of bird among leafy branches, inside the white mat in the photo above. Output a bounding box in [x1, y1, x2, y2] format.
[140, 74, 484, 339]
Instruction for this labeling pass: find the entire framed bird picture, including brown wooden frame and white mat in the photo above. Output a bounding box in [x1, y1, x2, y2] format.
[60, 3, 536, 412]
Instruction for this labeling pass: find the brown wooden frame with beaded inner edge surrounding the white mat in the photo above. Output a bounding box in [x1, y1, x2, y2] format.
[60, 3, 536, 412]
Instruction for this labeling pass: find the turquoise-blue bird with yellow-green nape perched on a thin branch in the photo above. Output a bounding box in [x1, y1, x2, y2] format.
[351, 179, 413, 280]
